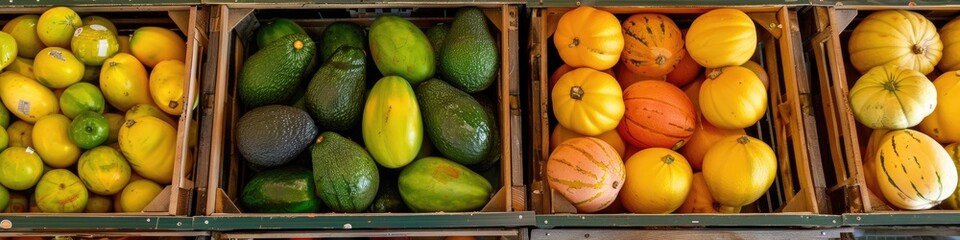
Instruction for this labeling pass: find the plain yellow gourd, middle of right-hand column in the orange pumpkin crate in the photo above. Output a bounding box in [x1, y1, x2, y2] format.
[700, 66, 767, 129]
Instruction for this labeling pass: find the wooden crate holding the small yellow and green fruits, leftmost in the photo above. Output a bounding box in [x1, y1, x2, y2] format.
[0, 5, 209, 216]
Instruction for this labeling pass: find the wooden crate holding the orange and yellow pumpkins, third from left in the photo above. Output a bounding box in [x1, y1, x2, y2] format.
[530, 5, 831, 216]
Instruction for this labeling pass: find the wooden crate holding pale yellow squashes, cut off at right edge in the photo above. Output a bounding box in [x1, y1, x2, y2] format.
[810, 2, 960, 214]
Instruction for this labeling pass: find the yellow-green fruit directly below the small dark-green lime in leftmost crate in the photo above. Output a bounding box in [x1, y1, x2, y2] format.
[77, 146, 131, 195]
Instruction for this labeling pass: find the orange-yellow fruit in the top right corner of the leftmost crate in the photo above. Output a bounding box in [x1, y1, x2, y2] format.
[130, 27, 187, 67]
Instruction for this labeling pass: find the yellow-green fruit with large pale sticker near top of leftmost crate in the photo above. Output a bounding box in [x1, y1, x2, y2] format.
[70, 24, 120, 66]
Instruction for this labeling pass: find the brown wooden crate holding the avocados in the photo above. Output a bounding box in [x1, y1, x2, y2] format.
[197, 3, 526, 217]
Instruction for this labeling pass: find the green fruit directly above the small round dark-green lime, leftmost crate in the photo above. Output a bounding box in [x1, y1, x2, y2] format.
[60, 82, 106, 119]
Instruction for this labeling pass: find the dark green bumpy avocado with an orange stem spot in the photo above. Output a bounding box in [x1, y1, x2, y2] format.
[237, 33, 316, 108]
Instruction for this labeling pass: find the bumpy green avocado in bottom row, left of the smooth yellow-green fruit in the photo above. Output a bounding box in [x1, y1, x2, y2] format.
[310, 132, 380, 212]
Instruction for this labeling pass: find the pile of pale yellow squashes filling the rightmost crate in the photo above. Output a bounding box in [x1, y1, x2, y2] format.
[844, 10, 960, 210]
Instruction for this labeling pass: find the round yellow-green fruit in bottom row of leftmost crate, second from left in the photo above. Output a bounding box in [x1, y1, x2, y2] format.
[34, 169, 89, 213]
